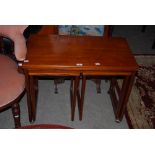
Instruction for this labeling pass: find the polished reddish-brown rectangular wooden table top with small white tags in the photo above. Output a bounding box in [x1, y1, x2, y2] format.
[23, 35, 138, 71]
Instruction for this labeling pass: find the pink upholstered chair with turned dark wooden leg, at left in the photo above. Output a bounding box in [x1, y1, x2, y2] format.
[0, 26, 27, 128]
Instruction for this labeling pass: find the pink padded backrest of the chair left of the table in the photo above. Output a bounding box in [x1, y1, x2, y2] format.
[0, 25, 27, 61]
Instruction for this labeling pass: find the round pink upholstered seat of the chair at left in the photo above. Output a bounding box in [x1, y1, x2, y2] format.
[0, 55, 25, 107]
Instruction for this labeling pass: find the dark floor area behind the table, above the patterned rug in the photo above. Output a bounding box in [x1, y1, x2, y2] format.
[112, 25, 155, 54]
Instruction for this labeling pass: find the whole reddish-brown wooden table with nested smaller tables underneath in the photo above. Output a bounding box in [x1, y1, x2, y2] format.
[20, 35, 138, 121]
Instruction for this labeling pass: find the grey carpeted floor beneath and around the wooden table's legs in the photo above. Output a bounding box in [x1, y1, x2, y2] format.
[0, 80, 128, 129]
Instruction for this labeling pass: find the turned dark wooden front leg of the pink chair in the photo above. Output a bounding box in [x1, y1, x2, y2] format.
[12, 103, 21, 128]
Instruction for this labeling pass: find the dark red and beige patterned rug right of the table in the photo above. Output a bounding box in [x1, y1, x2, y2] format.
[126, 56, 155, 129]
